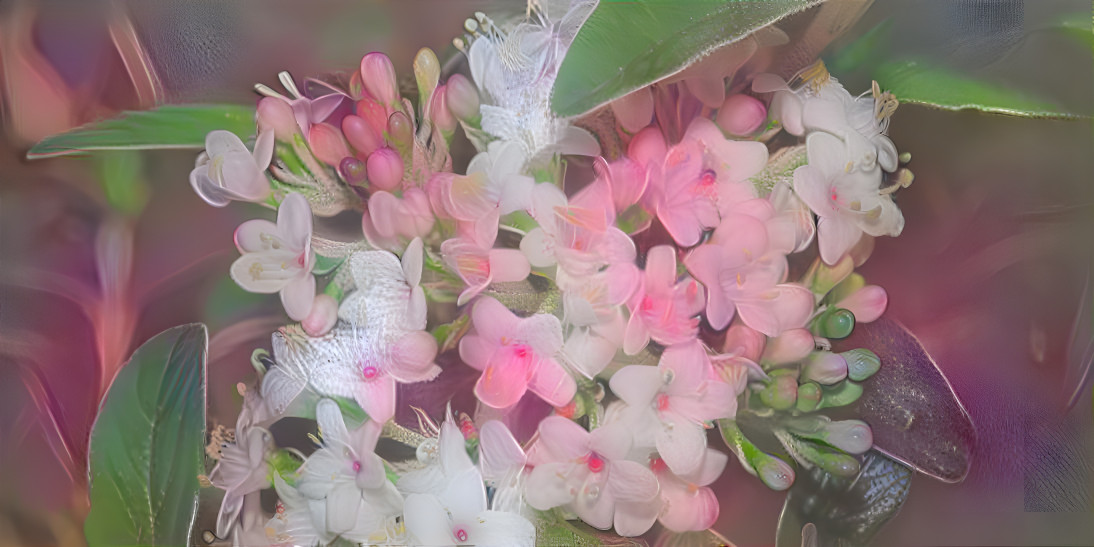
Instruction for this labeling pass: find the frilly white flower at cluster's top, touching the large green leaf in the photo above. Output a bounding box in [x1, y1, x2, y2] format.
[467, 1, 600, 161]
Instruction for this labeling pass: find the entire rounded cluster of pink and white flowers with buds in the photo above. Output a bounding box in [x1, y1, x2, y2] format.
[190, 2, 910, 545]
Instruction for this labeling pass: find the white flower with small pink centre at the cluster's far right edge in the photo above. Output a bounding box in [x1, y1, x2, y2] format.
[794, 132, 904, 264]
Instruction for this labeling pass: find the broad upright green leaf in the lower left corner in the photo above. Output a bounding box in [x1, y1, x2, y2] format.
[84, 324, 208, 547]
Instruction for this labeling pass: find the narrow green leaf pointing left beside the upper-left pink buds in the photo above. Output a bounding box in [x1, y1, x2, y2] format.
[26, 104, 255, 160]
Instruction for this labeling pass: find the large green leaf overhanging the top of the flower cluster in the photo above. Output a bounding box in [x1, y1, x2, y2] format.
[550, 0, 821, 117]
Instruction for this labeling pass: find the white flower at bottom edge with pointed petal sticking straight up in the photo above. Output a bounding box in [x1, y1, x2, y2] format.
[398, 410, 536, 547]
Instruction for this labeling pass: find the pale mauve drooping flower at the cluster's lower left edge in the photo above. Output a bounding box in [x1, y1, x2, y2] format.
[209, 427, 274, 537]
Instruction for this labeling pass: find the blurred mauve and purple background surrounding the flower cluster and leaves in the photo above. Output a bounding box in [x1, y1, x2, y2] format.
[0, 0, 1094, 547]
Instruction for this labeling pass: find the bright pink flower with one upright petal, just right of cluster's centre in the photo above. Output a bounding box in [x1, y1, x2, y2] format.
[622, 245, 705, 356]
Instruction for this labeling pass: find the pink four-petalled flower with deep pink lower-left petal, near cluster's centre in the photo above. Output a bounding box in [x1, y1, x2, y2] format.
[459, 298, 578, 408]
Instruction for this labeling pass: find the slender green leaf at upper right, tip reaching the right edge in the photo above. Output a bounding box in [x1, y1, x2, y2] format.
[874, 60, 1087, 119]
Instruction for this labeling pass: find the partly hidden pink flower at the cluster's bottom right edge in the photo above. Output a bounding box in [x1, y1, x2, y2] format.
[650, 449, 729, 532]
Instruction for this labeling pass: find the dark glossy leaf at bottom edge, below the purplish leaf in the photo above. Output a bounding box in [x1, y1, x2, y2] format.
[776, 451, 911, 547]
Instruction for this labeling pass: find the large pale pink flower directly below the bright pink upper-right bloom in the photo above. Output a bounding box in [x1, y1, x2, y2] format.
[684, 199, 814, 336]
